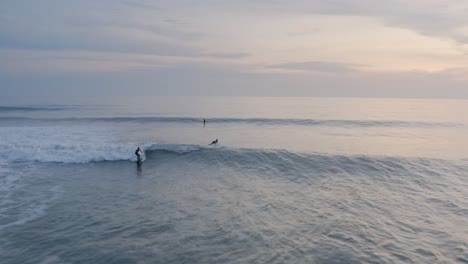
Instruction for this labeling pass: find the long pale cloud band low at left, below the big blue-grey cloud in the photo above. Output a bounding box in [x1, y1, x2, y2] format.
[0, 48, 248, 74]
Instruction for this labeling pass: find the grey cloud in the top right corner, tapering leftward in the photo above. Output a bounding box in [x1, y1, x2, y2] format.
[266, 0, 468, 43]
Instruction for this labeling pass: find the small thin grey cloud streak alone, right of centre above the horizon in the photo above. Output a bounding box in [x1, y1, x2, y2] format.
[267, 61, 362, 73]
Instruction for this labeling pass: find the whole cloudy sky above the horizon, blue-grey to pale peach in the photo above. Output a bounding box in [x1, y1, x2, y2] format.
[0, 0, 468, 103]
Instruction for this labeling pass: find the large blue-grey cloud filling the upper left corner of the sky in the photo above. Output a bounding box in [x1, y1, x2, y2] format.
[0, 0, 203, 57]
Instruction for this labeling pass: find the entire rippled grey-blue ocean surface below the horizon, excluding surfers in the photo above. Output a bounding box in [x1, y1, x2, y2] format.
[0, 97, 468, 264]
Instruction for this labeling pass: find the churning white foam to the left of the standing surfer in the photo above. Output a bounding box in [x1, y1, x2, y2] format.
[0, 127, 206, 163]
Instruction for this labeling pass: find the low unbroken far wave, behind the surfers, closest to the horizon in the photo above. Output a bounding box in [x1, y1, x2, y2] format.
[0, 116, 464, 128]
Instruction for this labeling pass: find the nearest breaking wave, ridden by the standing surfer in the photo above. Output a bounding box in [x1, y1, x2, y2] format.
[0, 140, 468, 175]
